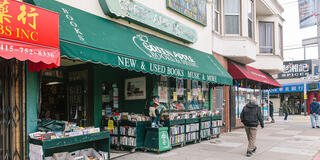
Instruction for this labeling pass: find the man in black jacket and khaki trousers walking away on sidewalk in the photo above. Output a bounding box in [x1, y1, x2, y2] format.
[240, 96, 264, 157]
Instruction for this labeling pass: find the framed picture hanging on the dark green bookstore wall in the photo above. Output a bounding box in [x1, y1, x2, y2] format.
[125, 77, 146, 100]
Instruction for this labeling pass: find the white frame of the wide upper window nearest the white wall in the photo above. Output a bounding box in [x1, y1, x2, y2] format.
[223, 0, 242, 36]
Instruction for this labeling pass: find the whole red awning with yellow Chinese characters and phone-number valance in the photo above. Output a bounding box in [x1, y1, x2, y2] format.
[0, 0, 60, 67]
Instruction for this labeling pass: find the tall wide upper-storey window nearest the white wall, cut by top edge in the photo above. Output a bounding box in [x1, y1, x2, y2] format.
[224, 0, 241, 34]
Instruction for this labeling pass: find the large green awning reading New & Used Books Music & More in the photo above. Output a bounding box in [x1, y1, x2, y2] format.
[33, 0, 232, 85]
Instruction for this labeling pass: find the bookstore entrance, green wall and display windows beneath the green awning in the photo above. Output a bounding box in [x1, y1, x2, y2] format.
[38, 59, 214, 126]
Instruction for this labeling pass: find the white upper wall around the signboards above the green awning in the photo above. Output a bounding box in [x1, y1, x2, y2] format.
[57, 0, 212, 54]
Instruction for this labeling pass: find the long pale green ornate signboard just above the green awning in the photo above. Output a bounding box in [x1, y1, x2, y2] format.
[99, 0, 197, 43]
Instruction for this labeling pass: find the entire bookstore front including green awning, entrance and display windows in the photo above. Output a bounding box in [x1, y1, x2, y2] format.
[26, 1, 232, 155]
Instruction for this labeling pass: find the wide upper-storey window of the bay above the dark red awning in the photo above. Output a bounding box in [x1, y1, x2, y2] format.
[259, 22, 273, 54]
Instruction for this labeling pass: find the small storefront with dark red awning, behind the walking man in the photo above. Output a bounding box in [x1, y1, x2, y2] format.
[228, 61, 281, 127]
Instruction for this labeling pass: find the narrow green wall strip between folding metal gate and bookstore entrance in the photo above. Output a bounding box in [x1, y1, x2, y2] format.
[25, 63, 39, 156]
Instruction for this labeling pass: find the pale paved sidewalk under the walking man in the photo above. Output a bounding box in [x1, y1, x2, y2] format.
[116, 115, 320, 160]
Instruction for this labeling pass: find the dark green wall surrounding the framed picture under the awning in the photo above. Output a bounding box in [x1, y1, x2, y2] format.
[93, 65, 156, 127]
